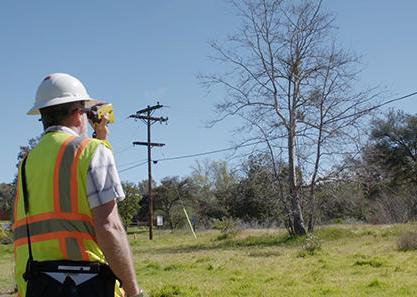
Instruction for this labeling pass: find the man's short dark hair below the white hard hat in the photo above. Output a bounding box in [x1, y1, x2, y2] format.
[39, 101, 84, 130]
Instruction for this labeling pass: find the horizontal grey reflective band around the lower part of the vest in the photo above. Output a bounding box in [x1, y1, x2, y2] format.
[13, 219, 95, 240]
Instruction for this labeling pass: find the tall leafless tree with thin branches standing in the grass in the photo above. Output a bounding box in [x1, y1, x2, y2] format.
[200, 0, 373, 235]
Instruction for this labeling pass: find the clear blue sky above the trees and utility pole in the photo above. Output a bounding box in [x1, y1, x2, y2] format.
[0, 0, 417, 182]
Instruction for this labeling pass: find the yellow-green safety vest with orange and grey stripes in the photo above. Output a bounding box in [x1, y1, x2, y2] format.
[13, 131, 120, 297]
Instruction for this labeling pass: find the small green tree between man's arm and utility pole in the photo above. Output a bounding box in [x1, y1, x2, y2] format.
[117, 182, 142, 230]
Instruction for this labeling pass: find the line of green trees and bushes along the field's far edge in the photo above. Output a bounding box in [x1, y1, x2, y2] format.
[117, 111, 417, 229]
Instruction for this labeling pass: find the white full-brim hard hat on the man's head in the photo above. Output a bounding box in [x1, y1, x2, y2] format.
[27, 73, 98, 115]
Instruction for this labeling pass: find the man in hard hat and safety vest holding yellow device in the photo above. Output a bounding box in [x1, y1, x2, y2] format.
[13, 73, 143, 297]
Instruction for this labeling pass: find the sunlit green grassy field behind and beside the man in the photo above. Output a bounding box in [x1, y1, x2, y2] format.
[0, 225, 417, 297]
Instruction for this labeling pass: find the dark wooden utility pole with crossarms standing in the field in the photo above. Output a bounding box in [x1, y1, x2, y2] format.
[129, 102, 168, 240]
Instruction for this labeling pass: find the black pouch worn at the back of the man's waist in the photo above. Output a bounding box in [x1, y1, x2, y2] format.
[24, 260, 116, 297]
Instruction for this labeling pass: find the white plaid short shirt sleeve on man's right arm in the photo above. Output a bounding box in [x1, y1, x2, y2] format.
[87, 144, 125, 208]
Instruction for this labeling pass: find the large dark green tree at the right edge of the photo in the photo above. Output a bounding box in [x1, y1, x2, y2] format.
[351, 110, 417, 223]
